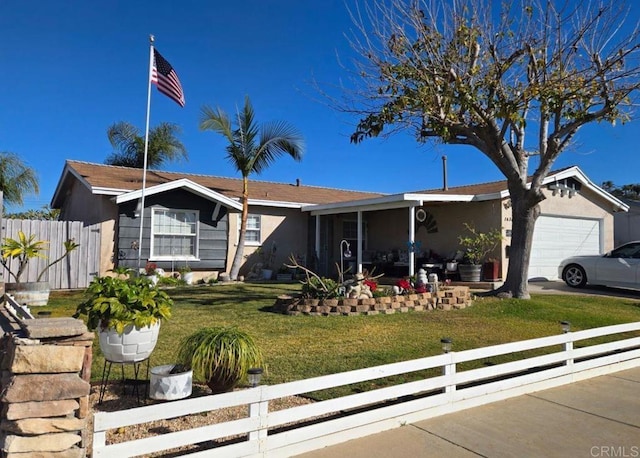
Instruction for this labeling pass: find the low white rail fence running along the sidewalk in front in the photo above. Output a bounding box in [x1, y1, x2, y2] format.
[93, 322, 640, 458]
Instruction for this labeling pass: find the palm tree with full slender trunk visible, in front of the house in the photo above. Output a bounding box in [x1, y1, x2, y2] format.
[200, 96, 304, 280]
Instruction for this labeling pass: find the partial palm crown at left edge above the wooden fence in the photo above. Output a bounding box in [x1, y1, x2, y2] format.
[0, 151, 40, 205]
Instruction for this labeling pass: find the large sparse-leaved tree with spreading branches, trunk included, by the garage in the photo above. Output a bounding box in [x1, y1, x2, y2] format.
[342, 0, 640, 298]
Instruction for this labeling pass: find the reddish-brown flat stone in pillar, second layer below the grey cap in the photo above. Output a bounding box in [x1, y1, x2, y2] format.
[0, 374, 91, 402]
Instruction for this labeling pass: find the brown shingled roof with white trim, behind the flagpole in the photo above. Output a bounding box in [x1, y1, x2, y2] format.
[51, 160, 383, 208]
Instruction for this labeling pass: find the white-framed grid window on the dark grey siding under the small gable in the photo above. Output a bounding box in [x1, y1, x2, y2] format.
[151, 208, 199, 259]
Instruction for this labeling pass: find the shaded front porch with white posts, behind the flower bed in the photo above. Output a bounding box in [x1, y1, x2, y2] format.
[305, 194, 509, 281]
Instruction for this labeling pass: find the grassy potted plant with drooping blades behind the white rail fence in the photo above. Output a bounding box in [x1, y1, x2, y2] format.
[176, 327, 264, 394]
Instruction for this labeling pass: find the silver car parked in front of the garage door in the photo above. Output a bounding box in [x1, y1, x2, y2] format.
[558, 241, 640, 289]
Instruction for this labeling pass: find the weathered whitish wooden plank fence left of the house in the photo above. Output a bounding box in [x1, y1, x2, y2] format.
[0, 218, 100, 289]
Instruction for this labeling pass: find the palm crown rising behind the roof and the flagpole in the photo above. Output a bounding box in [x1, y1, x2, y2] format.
[105, 121, 188, 169]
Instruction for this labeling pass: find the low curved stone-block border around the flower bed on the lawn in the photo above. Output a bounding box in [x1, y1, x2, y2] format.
[273, 286, 472, 315]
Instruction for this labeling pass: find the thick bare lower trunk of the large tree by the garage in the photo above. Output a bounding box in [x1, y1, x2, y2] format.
[499, 185, 540, 299]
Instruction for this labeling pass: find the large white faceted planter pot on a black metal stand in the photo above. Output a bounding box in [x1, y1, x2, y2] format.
[98, 320, 160, 363]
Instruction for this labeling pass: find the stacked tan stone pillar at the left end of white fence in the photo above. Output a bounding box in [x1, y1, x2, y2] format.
[0, 304, 94, 458]
